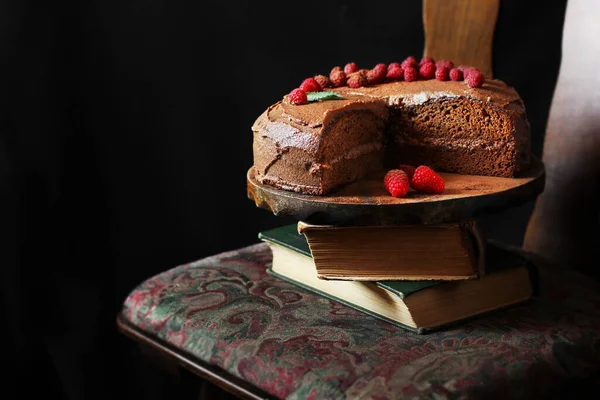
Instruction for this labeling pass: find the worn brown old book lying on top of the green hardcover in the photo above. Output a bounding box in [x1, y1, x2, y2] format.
[298, 220, 485, 281]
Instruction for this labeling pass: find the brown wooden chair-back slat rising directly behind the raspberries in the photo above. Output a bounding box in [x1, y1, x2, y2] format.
[423, 0, 500, 78]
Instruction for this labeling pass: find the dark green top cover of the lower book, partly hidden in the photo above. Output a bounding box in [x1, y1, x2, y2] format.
[258, 224, 525, 299]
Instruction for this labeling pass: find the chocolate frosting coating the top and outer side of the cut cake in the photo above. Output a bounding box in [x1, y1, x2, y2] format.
[252, 79, 529, 195]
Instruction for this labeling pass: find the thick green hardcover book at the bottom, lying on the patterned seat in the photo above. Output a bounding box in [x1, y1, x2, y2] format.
[259, 224, 535, 333]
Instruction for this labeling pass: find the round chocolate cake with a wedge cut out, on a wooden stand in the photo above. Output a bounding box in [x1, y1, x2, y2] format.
[252, 70, 530, 195]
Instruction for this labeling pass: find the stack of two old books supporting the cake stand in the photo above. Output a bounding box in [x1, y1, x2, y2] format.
[259, 222, 536, 333]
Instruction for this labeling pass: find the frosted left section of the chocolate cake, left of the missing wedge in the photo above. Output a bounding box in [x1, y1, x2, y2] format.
[252, 94, 388, 195]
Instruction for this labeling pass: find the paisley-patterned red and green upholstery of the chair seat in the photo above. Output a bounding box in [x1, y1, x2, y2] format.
[122, 243, 600, 399]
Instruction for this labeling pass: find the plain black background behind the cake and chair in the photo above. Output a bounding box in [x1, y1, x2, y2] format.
[0, 0, 566, 399]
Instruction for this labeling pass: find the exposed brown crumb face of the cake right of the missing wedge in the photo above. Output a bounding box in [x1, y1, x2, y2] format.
[388, 97, 517, 177]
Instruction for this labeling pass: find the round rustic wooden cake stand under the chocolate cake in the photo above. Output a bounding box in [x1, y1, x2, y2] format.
[247, 158, 545, 226]
